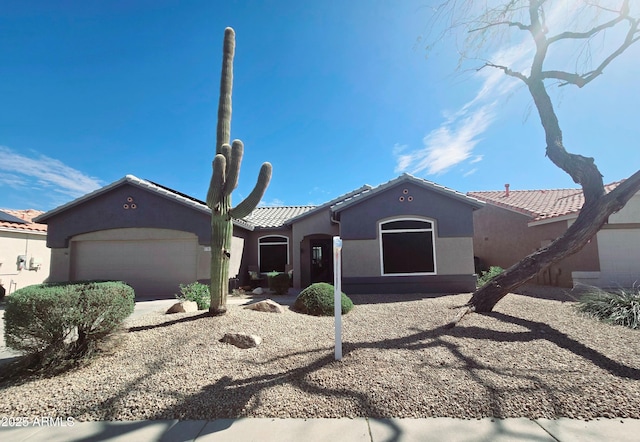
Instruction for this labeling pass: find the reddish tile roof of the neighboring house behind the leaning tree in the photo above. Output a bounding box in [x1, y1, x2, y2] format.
[467, 181, 622, 221]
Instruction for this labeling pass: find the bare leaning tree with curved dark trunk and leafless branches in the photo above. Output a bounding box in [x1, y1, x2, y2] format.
[424, 0, 640, 326]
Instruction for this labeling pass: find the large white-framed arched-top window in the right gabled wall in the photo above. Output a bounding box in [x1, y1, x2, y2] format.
[380, 218, 436, 275]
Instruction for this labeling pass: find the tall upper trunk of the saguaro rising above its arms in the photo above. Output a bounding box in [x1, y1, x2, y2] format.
[216, 28, 236, 153]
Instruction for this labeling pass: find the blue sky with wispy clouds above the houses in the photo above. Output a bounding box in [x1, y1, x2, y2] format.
[0, 0, 640, 210]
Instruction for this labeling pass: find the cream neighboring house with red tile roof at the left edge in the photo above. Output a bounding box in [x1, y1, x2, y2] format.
[0, 209, 51, 294]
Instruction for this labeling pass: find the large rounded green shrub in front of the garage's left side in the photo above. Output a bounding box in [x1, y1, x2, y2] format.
[4, 282, 135, 365]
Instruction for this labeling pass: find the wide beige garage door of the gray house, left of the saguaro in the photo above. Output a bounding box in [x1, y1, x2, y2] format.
[72, 238, 198, 297]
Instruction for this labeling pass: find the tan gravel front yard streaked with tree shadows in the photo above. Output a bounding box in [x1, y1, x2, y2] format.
[0, 294, 640, 421]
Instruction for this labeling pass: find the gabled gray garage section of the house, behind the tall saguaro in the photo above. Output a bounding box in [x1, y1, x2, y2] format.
[33, 175, 240, 298]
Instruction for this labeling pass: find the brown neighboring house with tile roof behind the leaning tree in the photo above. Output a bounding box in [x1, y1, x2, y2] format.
[468, 182, 640, 288]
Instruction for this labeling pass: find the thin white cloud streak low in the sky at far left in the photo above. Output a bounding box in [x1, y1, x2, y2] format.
[0, 146, 102, 198]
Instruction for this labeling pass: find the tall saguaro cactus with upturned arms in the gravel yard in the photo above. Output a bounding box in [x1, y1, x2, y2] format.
[207, 28, 271, 315]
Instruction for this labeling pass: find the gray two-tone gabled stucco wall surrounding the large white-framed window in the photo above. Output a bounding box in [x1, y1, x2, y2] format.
[339, 182, 476, 294]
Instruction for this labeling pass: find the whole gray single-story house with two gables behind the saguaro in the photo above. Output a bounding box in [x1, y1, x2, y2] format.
[38, 174, 484, 296]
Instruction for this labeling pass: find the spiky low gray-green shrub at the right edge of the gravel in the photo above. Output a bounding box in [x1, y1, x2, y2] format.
[577, 288, 640, 329]
